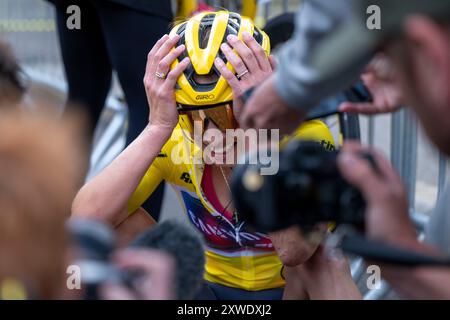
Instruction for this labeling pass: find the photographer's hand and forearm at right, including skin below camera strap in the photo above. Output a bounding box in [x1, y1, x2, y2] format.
[338, 143, 450, 299]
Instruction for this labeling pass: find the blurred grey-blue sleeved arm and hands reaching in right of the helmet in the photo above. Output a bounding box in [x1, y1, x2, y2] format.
[238, 0, 401, 133]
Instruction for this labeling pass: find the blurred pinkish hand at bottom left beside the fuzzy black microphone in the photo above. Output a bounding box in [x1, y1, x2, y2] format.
[100, 249, 175, 300]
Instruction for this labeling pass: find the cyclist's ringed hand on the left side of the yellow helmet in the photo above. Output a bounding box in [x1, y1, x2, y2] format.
[144, 35, 189, 132]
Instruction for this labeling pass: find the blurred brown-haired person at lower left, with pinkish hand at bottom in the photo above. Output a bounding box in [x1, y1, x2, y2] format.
[0, 108, 173, 300]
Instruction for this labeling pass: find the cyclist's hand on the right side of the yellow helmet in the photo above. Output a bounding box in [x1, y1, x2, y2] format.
[214, 32, 275, 119]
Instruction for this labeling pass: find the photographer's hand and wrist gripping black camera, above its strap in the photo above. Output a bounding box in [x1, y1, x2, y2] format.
[338, 142, 416, 247]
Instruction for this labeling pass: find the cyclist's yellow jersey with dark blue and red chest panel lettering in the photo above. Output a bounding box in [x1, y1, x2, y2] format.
[128, 120, 334, 291]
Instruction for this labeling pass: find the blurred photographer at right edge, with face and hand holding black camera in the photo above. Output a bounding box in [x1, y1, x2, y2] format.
[313, 0, 450, 299]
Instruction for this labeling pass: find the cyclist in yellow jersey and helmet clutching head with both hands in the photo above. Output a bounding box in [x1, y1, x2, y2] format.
[73, 11, 360, 299]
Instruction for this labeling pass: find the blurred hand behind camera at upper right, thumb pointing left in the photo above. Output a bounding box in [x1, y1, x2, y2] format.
[339, 53, 402, 114]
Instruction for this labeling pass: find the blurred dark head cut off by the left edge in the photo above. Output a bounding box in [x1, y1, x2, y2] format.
[0, 42, 26, 108]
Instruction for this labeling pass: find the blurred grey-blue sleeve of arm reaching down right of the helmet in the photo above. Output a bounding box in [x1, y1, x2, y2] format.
[274, 0, 370, 112]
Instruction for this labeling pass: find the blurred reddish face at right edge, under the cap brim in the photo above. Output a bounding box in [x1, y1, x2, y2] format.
[387, 16, 450, 154]
